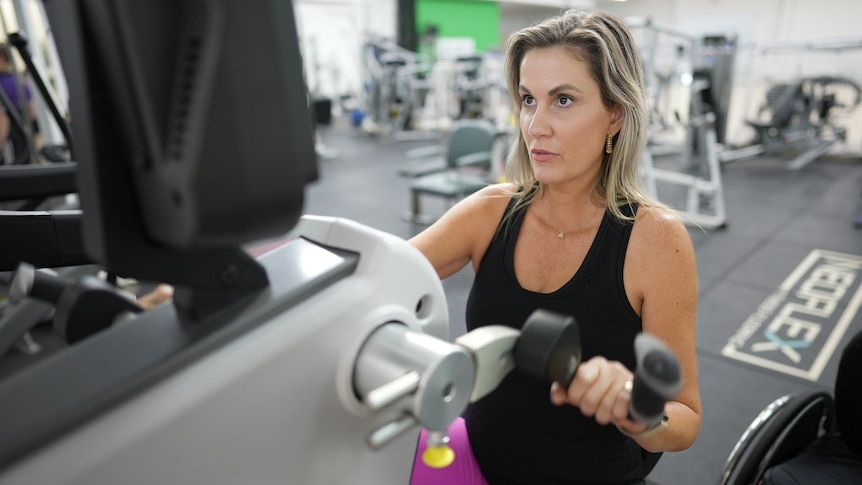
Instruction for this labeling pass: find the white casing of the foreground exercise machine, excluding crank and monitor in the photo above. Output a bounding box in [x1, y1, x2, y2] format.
[0, 216, 452, 485]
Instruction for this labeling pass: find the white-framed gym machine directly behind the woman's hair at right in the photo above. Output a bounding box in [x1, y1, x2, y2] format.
[627, 18, 735, 229]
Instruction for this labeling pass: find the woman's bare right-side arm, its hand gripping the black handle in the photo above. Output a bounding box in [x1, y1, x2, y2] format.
[551, 209, 701, 452]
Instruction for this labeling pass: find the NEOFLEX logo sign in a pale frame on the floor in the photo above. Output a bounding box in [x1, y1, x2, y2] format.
[721, 249, 862, 381]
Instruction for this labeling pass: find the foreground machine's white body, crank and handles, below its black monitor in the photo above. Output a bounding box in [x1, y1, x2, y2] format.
[0, 216, 681, 484]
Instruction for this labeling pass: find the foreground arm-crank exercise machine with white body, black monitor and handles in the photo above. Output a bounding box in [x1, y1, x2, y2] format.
[0, 0, 681, 485]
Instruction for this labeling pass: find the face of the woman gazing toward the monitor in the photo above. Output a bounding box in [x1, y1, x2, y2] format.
[518, 47, 623, 185]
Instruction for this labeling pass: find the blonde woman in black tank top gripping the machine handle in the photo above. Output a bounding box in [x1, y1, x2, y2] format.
[411, 11, 701, 485]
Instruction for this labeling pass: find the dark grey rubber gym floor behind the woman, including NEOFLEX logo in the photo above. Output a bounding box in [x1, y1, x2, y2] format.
[304, 120, 862, 485]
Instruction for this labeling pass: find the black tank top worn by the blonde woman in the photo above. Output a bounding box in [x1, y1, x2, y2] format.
[464, 201, 643, 485]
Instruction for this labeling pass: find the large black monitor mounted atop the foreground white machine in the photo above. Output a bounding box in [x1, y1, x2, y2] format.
[44, 0, 317, 313]
